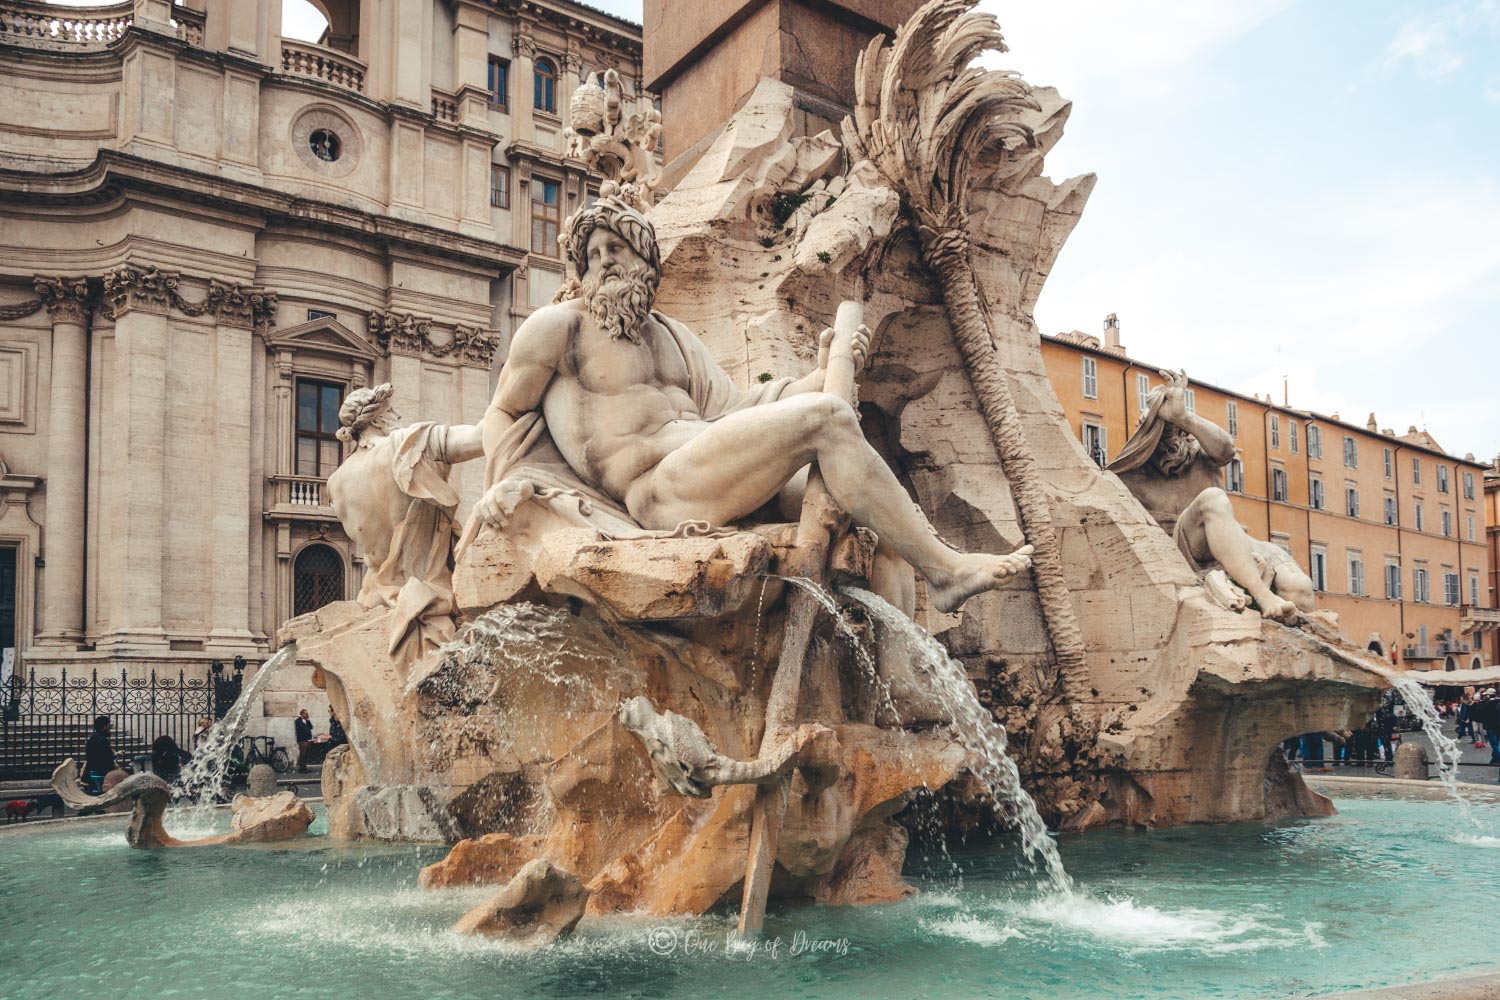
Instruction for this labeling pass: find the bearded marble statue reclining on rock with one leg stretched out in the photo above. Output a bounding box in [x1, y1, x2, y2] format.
[465, 198, 1031, 612]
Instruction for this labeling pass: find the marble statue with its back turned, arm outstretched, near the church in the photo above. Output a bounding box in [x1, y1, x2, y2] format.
[329, 384, 483, 663]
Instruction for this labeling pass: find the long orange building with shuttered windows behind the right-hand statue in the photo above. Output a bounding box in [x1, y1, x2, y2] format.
[1041, 313, 1500, 670]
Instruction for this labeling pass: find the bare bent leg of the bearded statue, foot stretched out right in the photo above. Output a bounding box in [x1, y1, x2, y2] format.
[626, 393, 1031, 612]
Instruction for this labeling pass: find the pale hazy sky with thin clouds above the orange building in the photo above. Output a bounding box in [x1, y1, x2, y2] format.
[276, 0, 1500, 459]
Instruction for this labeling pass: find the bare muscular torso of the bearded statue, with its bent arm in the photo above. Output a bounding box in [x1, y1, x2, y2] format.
[497, 300, 708, 507]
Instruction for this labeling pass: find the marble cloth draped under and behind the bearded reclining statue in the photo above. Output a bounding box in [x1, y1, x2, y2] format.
[459, 310, 795, 555]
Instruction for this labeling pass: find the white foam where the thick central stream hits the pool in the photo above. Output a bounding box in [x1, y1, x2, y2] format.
[1019, 894, 1326, 955]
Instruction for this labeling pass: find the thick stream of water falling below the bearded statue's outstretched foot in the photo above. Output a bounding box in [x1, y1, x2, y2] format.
[840, 586, 1073, 897]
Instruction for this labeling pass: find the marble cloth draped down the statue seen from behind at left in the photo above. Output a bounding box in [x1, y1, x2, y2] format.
[359, 420, 459, 663]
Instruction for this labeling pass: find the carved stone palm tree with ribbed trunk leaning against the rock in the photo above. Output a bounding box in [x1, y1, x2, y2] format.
[843, 0, 1089, 703]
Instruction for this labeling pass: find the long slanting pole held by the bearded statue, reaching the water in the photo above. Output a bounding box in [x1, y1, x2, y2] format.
[740, 300, 864, 934]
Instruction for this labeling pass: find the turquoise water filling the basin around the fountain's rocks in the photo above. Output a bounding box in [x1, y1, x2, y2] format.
[0, 798, 1500, 1000]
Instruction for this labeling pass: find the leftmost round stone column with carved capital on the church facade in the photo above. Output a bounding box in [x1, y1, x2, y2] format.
[36, 277, 90, 645]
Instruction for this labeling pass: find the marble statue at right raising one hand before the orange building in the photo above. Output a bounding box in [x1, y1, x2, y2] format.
[1107, 372, 1313, 619]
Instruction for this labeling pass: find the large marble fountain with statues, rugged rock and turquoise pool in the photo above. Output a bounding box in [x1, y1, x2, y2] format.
[0, 0, 1494, 997]
